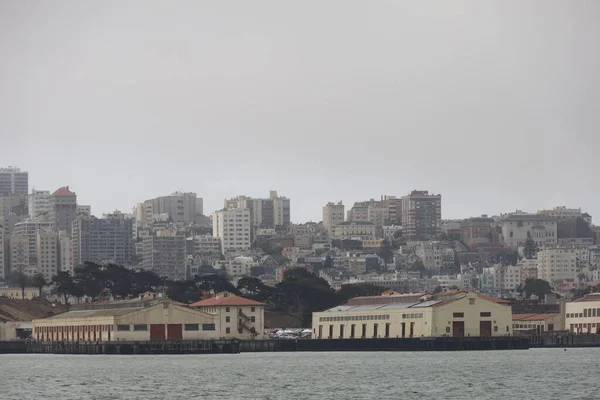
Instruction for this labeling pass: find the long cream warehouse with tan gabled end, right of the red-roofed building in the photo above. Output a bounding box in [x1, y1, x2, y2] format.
[312, 291, 513, 339]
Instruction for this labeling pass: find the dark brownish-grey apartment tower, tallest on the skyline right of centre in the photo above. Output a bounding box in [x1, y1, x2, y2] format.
[402, 190, 442, 240]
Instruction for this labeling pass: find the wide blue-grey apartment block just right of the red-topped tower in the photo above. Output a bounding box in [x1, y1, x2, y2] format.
[72, 211, 134, 265]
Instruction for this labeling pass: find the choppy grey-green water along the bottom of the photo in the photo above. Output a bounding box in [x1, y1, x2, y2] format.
[0, 349, 600, 400]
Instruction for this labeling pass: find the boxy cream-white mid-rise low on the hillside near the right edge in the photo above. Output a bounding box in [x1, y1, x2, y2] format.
[537, 247, 578, 285]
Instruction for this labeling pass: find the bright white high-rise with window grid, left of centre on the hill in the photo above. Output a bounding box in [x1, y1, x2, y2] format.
[213, 206, 251, 254]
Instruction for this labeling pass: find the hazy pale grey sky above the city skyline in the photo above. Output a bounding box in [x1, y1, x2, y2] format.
[0, 0, 600, 221]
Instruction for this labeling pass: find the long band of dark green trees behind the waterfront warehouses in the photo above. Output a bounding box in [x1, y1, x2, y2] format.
[8, 263, 384, 326]
